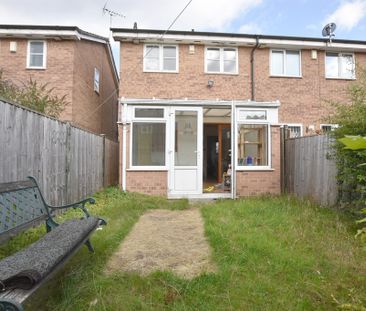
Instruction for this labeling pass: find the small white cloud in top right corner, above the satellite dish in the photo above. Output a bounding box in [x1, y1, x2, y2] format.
[325, 0, 366, 31]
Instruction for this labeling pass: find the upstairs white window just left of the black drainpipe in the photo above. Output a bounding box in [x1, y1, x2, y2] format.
[205, 47, 238, 74]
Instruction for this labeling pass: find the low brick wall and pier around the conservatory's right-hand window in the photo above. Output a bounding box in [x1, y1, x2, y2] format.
[236, 126, 281, 197]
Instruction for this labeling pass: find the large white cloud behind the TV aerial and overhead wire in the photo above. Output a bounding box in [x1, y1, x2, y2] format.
[0, 0, 262, 36]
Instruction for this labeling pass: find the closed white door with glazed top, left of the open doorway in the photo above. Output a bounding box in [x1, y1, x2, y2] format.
[168, 107, 203, 197]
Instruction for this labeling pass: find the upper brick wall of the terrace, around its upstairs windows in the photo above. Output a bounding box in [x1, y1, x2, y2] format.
[120, 43, 366, 127]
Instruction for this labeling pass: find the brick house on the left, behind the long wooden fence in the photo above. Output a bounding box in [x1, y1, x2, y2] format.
[0, 25, 119, 140]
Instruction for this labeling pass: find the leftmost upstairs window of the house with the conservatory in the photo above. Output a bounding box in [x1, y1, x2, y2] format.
[144, 44, 178, 72]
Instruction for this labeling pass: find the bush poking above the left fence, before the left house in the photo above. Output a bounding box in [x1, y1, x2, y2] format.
[0, 70, 67, 118]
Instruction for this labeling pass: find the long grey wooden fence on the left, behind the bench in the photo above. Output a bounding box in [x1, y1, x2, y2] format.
[0, 101, 118, 204]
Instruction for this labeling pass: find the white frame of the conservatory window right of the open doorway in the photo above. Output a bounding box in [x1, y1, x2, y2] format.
[234, 108, 273, 171]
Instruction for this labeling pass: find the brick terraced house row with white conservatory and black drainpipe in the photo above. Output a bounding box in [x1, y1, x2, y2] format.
[112, 28, 366, 198]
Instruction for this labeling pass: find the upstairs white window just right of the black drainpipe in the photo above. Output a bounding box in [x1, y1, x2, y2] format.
[271, 50, 301, 77]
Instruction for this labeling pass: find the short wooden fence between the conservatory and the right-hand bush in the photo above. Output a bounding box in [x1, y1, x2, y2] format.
[285, 135, 338, 205]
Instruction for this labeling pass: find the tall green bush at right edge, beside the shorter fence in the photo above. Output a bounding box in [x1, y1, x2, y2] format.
[328, 69, 366, 208]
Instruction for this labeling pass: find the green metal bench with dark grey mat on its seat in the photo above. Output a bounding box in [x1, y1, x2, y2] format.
[0, 177, 106, 311]
